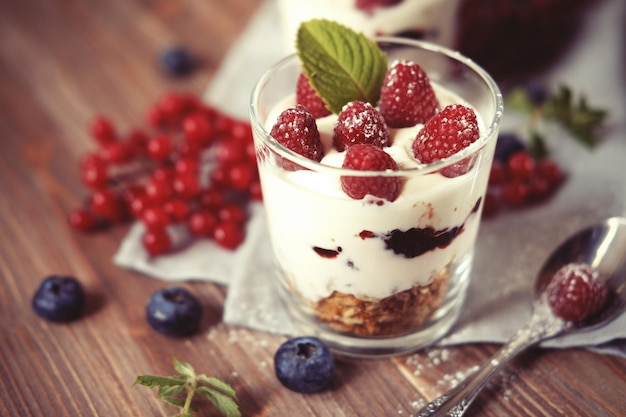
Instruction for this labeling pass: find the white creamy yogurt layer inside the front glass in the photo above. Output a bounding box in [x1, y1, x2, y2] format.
[259, 85, 491, 302]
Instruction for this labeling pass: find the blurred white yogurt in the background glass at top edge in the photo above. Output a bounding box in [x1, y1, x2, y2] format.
[278, 0, 459, 47]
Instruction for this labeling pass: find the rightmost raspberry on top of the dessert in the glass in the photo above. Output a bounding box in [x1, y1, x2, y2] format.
[413, 104, 480, 177]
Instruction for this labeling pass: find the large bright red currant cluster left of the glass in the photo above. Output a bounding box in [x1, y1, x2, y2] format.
[69, 92, 262, 255]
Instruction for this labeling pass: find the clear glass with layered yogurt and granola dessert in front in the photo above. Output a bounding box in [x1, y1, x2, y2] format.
[250, 37, 503, 357]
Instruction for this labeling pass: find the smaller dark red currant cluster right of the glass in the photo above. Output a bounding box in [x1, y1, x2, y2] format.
[483, 150, 564, 217]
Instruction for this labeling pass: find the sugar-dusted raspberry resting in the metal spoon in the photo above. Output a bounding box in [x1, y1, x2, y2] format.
[546, 263, 608, 322]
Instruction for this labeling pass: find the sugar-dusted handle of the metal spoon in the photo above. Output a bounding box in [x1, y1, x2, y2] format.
[413, 314, 552, 417]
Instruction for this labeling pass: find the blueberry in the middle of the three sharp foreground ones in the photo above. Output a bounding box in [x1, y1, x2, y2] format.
[146, 287, 202, 337]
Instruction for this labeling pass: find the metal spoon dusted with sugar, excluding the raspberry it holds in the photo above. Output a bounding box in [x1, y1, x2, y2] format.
[413, 217, 626, 417]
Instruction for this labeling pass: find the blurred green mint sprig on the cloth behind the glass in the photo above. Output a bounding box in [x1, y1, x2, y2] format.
[506, 85, 608, 154]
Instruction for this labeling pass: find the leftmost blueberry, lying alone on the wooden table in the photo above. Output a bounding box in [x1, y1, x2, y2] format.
[32, 275, 85, 322]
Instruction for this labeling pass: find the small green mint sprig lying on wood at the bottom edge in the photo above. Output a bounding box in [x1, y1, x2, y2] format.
[132, 359, 241, 417]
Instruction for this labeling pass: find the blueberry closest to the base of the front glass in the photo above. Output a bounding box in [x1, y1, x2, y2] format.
[274, 337, 335, 393]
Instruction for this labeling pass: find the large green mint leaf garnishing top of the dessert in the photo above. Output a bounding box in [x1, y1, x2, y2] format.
[296, 19, 387, 113]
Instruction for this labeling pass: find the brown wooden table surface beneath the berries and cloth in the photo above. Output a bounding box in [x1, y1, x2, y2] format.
[0, 0, 626, 417]
